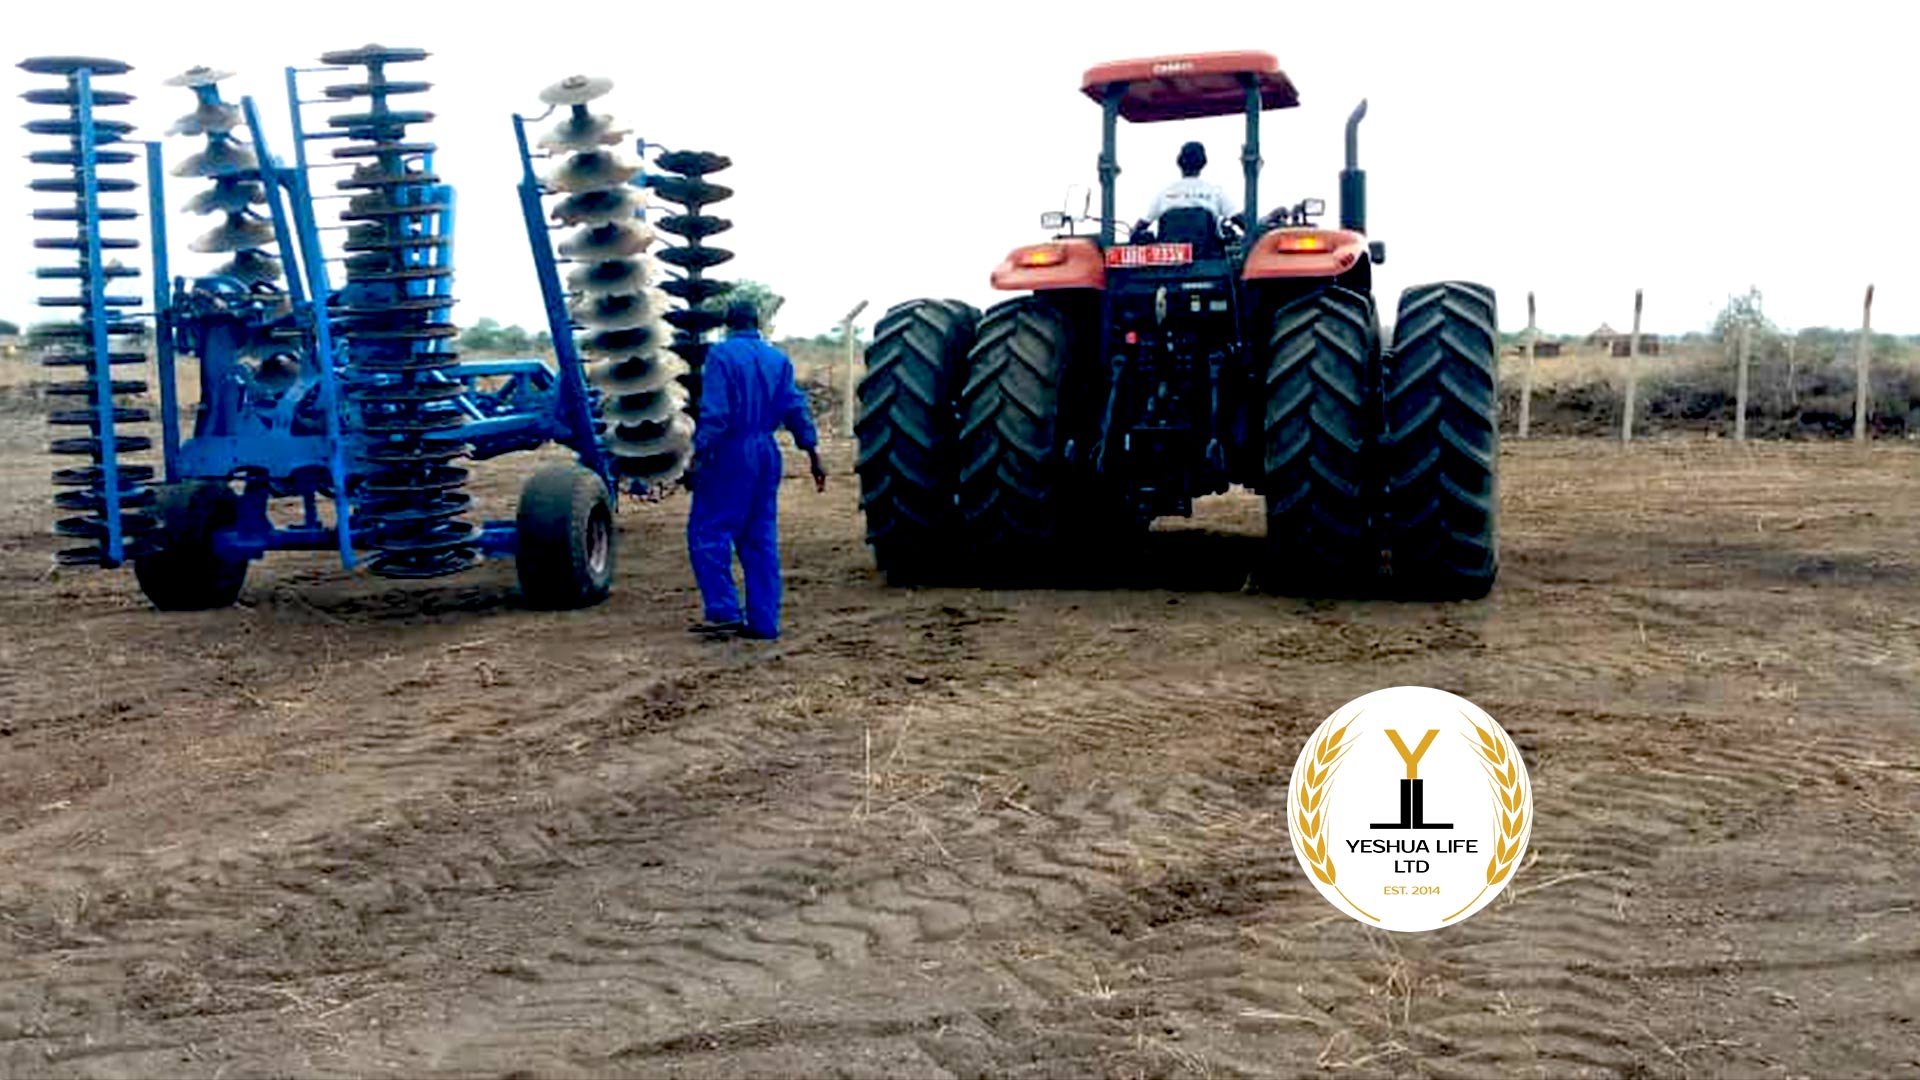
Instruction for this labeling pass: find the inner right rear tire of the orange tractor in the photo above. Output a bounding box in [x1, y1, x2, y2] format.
[1261, 286, 1380, 596]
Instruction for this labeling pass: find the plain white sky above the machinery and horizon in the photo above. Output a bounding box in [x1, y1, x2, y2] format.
[0, 0, 1920, 334]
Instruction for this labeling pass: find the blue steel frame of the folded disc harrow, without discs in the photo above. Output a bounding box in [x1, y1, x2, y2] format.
[136, 67, 618, 569]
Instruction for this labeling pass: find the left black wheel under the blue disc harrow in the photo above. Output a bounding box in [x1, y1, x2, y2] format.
[132, 480, 250, 611]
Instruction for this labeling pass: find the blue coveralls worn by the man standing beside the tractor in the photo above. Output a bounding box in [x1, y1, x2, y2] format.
[687, 322, 820, 638]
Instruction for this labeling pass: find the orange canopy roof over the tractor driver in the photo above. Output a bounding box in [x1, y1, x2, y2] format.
[1081, 52, 1300, 123]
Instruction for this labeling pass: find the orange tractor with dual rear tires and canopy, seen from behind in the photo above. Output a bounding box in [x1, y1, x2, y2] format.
[856, 52, 1500, 598]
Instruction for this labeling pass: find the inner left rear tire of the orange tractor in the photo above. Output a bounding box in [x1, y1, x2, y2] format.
[958, 296, 1069, 575]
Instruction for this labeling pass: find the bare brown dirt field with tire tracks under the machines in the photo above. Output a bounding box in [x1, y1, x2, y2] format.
[0, 413, 1920, 1076]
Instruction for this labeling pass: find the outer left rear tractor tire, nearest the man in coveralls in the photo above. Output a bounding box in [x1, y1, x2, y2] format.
[854, 300, 979, 584]
